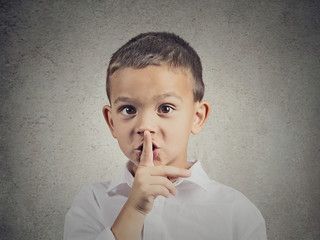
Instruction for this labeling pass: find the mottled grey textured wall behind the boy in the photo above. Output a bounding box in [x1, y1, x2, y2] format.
[0, 0, 320, 240]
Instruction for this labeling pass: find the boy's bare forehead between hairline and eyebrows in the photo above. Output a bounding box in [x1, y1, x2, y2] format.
[109, 65, 193, 104]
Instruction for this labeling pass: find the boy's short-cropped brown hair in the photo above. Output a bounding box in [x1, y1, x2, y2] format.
[106, 32, 204, 103]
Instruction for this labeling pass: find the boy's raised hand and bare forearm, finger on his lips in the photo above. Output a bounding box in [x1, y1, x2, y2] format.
[111, 131, 191, 240]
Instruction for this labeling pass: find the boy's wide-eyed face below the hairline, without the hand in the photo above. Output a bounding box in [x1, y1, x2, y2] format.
[104, 65, 206, 170]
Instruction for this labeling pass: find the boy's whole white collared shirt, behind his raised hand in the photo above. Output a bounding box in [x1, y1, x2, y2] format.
[64, 161, 267, 240]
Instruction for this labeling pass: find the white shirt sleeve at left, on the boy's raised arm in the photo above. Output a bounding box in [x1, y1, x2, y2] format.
[63, 186, 115, 240]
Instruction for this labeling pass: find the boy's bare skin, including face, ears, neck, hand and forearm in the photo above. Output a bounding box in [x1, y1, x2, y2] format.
[103, 65, 210, 239]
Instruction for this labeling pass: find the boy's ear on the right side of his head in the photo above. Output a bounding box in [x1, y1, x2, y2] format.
[191, 101, 211, 134]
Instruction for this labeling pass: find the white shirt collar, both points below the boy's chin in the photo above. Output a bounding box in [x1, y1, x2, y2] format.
[107, 161, 209, 192]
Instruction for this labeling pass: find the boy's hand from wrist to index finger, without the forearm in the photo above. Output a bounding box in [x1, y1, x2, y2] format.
[127, 131, 191, 214]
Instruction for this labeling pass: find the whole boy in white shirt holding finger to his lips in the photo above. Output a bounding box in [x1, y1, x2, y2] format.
[64, 32, 266, 240]
